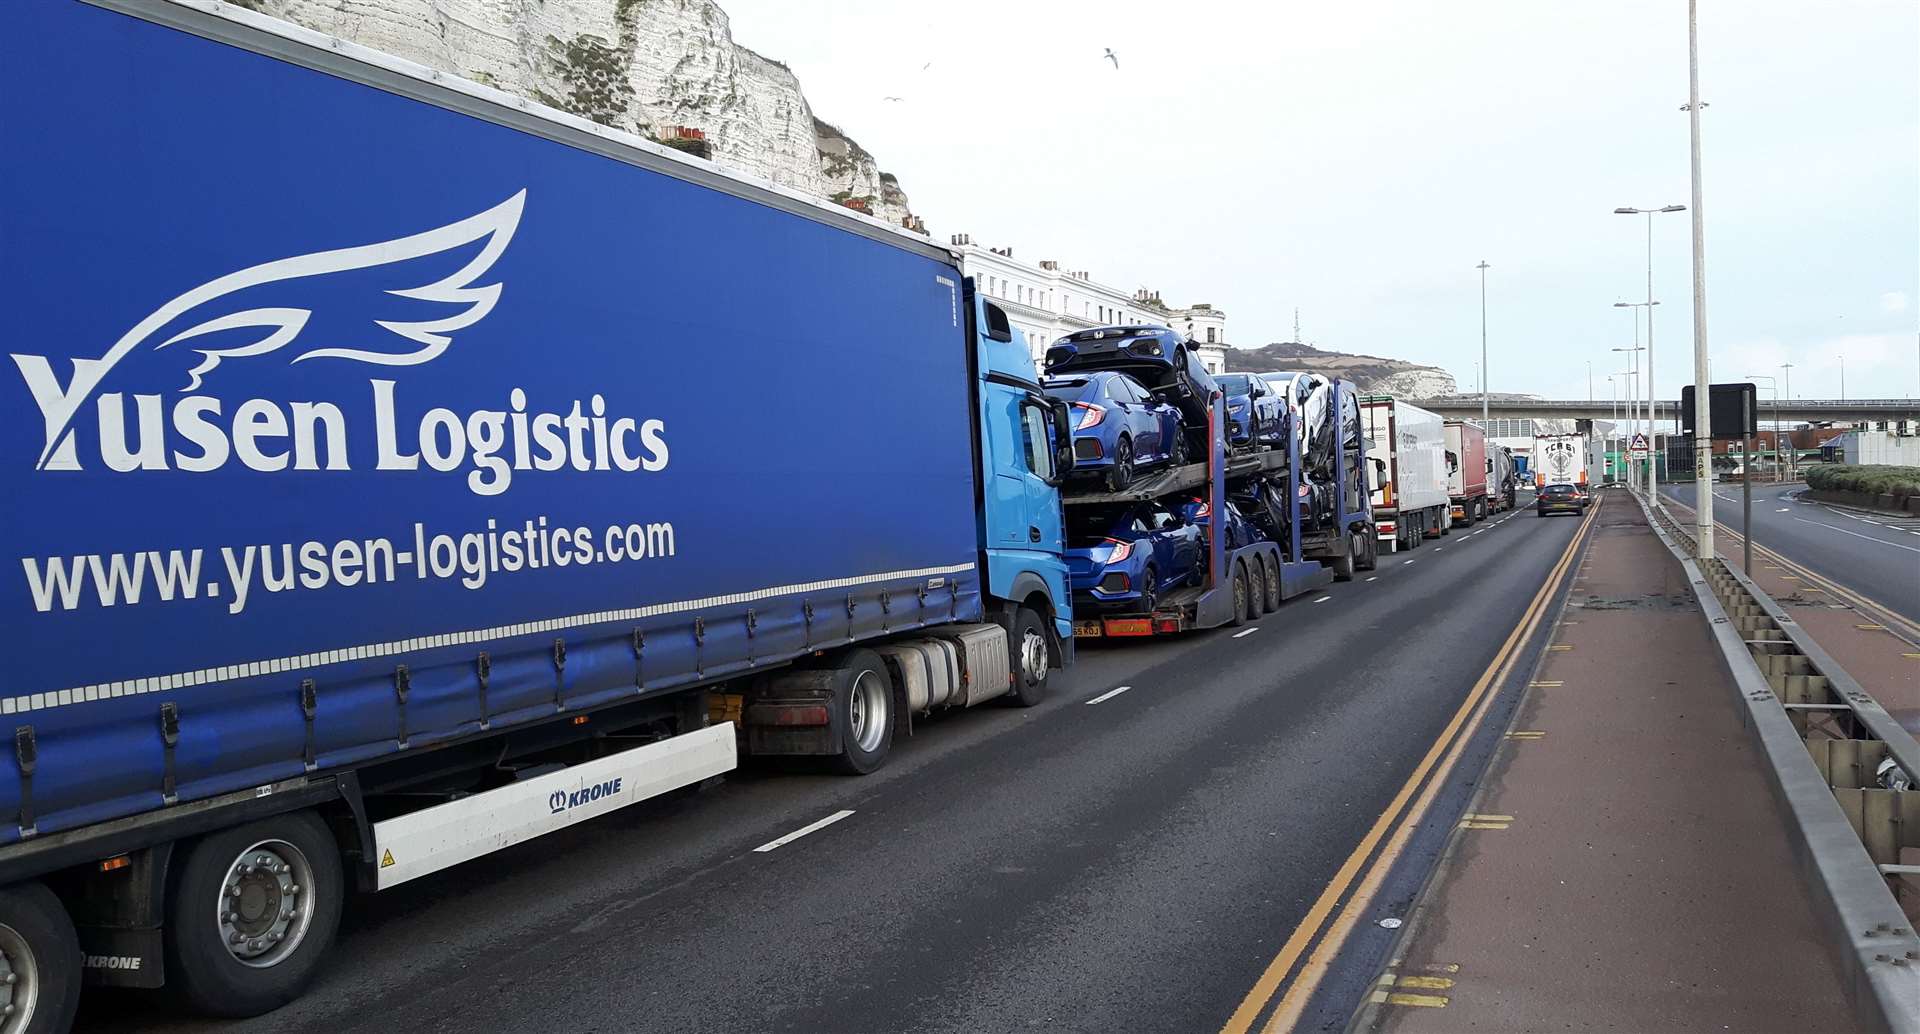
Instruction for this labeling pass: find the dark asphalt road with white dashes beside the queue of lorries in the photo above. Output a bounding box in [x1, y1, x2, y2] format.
[79, 510, 1582, 1034]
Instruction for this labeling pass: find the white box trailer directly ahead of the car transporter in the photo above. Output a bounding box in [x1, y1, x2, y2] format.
[1359, 395, 1452, 552]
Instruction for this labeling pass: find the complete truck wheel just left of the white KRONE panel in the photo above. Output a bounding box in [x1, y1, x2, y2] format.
[165, 811, 346, 1017]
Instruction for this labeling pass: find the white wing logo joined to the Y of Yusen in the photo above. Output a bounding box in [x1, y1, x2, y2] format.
[13, 190, 526, 470]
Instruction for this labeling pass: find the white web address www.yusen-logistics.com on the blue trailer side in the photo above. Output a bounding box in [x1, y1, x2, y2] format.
[21, 516, 674, 614]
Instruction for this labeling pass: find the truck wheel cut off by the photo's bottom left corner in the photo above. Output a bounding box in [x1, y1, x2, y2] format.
[0, 882, 81, 1034]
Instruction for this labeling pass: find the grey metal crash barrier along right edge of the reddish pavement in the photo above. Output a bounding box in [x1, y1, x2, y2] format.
[1640, 499, 1920, 1034]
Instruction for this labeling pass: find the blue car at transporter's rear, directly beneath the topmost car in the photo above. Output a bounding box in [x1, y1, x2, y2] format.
[1041, 370, 1187, 491]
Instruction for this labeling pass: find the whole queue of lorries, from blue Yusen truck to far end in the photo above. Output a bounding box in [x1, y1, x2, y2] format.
[0, 0, 1584, 1034]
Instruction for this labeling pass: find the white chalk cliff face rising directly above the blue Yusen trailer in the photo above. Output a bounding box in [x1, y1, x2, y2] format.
[236, 0, 916, 226]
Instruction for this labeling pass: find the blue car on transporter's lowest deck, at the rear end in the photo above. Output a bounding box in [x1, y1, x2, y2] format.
[1068, 503, 1206, 614]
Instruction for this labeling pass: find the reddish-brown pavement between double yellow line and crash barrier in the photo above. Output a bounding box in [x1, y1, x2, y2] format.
[1359, 497, 1857, 1034]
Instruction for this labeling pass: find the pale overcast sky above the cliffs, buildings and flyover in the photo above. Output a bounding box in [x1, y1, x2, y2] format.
[720, 0, 1920, 399]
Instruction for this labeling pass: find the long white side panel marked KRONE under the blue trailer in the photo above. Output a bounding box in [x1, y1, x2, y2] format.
[372, 721, 739, 890]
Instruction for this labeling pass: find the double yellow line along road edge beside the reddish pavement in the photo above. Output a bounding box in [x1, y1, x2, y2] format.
[1221, 489, 1603, 1034]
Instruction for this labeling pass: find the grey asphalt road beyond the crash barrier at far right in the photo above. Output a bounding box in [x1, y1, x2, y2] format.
[1661, 483, 1920, 623]
